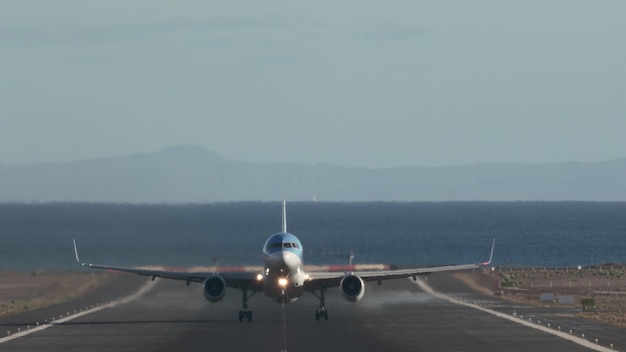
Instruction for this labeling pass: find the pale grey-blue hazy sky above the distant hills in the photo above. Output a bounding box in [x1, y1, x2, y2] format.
[0, 0, 626, 167]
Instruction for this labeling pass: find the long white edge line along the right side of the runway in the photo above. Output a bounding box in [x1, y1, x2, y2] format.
[411, 278, 614, 352]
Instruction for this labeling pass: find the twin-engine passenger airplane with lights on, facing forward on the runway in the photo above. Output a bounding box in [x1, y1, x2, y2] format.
[73, 201, 495, 322]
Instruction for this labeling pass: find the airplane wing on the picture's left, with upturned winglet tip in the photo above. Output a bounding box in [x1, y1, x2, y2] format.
[74, 240, 263, 291]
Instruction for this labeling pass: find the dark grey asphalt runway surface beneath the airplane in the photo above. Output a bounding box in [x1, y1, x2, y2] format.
[0, 274, 626, 352]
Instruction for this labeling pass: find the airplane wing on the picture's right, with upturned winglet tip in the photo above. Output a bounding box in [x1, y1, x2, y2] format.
[306, 239, 496, 289]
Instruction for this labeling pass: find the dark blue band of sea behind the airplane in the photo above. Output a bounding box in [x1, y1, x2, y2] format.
[0, 202, 626, 271]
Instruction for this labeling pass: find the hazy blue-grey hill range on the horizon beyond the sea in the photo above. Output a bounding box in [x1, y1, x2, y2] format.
[0, 146, 626, 203]
